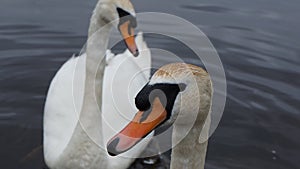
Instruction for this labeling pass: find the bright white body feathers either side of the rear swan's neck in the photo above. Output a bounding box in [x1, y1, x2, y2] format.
[44, 33, 152, 168]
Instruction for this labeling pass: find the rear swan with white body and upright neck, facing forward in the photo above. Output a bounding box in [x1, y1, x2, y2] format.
[43, 0, 151, 169]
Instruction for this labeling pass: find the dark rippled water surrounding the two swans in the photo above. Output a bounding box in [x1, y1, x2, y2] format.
[0, 0, 300, 169]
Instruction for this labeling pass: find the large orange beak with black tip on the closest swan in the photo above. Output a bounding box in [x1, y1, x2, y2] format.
[107, 98, 167, 156]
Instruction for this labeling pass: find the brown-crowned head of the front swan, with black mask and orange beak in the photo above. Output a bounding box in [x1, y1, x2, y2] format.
[107, 63, 211, 155]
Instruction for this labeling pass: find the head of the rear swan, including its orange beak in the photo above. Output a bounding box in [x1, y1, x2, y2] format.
[94, 0, 139, 56]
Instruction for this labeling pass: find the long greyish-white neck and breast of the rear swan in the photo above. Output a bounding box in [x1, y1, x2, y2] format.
[57, 2, 111, 168]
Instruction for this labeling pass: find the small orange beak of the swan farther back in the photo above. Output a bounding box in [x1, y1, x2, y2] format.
[119, 20, 139, 57]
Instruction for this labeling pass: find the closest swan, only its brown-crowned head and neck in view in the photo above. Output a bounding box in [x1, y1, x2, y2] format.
[107, 63, 212, 169]
